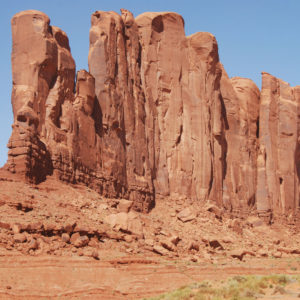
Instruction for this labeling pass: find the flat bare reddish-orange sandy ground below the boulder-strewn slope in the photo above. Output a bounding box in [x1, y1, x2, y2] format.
[0, 253, 300, 299]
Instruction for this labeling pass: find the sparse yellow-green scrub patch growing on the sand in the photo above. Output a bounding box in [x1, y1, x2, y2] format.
[144, 275, 300, 300]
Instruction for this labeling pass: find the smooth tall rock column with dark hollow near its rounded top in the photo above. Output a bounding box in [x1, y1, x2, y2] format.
[136, 12, 185, 196]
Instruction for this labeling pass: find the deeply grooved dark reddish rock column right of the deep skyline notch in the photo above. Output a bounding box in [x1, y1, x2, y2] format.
[89, 10, 154, 211]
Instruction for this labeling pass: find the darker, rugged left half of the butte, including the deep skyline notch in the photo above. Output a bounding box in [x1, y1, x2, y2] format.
[6, 10, 154, 211]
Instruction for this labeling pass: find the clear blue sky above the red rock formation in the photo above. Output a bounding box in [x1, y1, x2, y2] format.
[0, 0, 300, 166]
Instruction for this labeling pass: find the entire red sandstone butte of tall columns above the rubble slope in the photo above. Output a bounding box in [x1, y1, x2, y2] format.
[4, 9, 300, 218]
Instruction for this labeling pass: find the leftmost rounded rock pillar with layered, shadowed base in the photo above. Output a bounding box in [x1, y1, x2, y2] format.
[7, 10, 58, 182]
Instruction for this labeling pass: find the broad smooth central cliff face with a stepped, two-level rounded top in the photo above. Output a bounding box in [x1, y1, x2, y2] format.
[136, 13, 223, 204]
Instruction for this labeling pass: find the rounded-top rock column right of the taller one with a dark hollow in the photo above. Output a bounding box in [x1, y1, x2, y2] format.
[186, 32, 226, 205]
